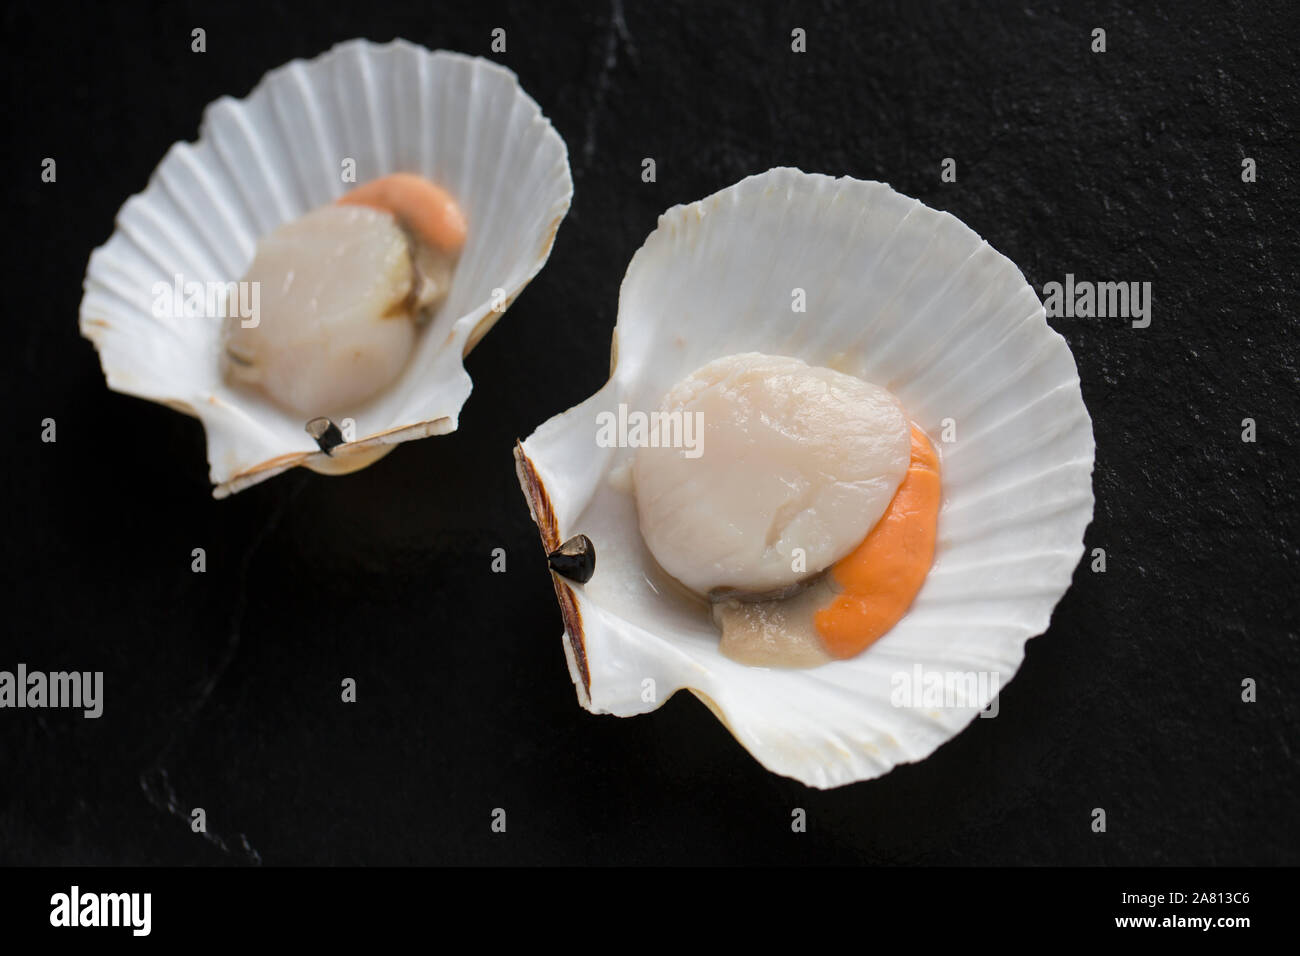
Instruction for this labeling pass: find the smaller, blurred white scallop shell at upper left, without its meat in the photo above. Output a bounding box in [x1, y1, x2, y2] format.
[81, 40, 573, 498]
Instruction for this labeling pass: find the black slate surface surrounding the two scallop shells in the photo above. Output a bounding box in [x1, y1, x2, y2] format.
[0, 0, 1300, 864]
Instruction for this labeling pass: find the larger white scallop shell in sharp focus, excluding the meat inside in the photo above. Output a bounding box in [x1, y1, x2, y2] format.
[516, 169, 1093, 787]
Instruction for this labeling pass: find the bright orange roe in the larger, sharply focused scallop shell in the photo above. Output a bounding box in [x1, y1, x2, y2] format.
[814, 427, 940, 659]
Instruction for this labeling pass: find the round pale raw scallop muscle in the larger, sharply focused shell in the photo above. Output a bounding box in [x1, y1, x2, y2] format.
[633, 352, 910, 594]
